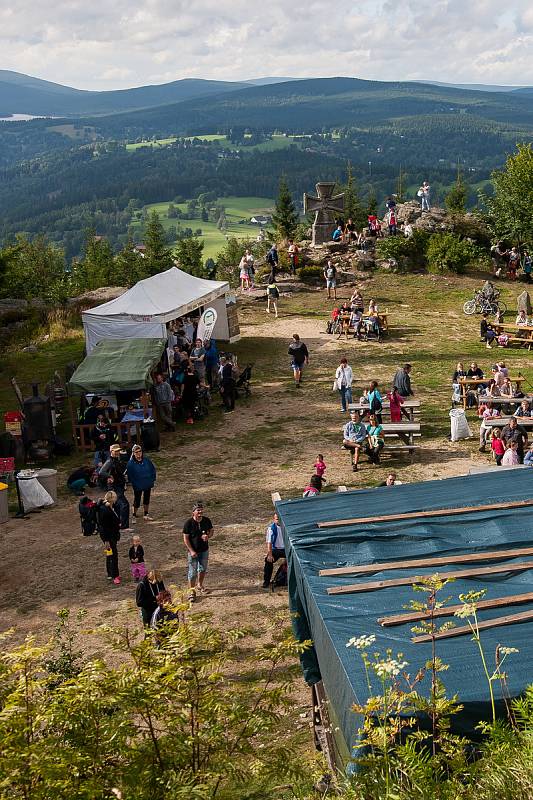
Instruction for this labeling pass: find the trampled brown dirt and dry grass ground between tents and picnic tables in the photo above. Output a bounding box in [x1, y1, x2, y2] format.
[0, 278, 522, 668]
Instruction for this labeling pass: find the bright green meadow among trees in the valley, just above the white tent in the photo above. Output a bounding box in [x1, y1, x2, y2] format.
[133, 197, 273, 258]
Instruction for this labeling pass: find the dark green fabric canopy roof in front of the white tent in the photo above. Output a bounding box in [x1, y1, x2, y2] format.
[68, 339, 166, 394]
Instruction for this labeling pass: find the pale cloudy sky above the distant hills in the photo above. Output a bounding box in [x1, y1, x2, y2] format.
[0, 0, 533, 89]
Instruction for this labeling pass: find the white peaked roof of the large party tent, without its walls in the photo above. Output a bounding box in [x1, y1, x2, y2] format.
[83, 267, 229, 321]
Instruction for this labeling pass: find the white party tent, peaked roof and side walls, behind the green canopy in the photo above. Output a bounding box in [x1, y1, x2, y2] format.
[82, 267, 239, 353]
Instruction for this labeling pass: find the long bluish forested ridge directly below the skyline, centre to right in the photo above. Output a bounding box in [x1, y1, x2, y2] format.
[80, 78, 533, 138]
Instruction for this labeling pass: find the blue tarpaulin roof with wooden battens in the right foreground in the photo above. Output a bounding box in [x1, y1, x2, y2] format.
[276, 470, 533, 768]
